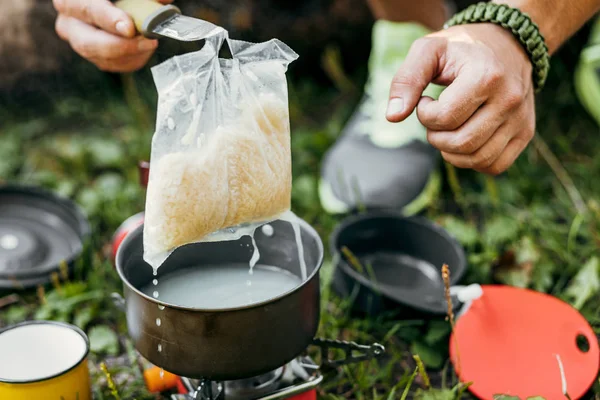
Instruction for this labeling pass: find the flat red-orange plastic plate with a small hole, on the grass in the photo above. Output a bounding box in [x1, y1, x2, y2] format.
[450, 285, 600, 400]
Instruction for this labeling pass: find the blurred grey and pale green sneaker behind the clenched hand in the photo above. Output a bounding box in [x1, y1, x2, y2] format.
[319, 20, 443, 214]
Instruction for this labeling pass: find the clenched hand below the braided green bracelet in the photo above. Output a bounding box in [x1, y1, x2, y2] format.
[387, 23, 535, 175]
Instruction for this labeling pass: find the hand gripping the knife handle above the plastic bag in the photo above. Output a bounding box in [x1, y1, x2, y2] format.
[53, 0, 172, 72]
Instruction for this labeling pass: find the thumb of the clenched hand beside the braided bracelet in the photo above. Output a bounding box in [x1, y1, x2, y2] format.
[386, 37, 446, 122]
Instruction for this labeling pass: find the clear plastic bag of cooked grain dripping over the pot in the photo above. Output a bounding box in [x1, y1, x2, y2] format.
[144, 25, 298, 269]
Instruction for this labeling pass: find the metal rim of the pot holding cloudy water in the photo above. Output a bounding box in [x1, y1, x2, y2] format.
[115, 218, 325, 313]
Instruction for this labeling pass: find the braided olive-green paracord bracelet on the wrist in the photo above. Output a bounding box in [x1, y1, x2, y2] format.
[444, 2, 550, 92]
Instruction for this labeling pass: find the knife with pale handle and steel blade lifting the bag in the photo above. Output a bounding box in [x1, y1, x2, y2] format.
[114, 0, 226, 42]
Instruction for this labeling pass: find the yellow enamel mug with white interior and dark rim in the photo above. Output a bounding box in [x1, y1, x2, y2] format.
[0, 321, 92, 400]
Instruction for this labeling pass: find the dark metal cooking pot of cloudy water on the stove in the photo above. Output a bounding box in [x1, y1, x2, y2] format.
[116, 221, 323, 381]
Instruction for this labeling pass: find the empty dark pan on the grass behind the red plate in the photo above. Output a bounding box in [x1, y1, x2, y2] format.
[330, 211, 466, 317]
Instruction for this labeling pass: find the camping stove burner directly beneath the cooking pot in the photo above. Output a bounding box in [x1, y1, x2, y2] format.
[171, 357, 323, 400]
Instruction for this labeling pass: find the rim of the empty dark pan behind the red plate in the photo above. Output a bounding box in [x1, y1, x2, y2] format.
[329, 210, 467, 313]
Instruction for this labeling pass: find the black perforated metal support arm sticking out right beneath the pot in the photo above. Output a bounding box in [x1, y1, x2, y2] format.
[312, 338, 385, 368]
